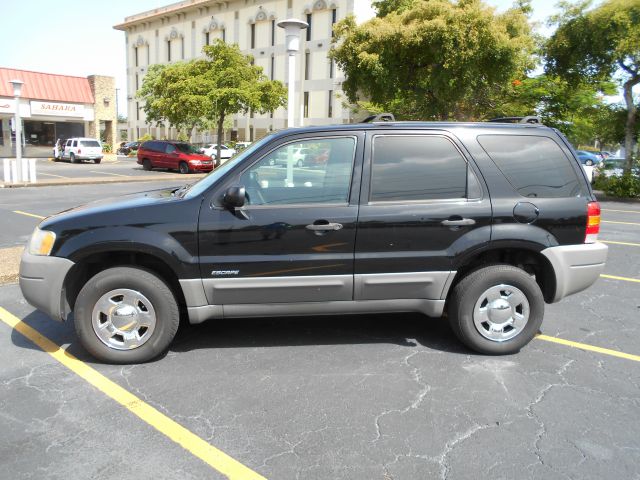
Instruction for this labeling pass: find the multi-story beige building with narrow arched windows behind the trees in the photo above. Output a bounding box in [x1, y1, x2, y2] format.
[114, 0, 373, 142]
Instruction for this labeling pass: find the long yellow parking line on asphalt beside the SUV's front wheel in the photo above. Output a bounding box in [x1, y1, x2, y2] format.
[0, 307, 264, 480]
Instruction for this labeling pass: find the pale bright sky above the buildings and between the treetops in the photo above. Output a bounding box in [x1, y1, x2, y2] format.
[0, 0, 584, 113]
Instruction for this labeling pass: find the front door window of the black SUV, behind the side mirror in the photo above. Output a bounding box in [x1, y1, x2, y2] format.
[240, 137, 356, 205]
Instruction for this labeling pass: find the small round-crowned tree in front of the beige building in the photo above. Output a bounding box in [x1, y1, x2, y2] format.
[138, 40, 286, 158]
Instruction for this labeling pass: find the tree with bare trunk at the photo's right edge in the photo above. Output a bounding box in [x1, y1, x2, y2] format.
[545, 0, 640, 172]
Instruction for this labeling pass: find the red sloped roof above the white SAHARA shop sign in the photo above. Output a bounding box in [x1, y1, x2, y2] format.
[0, 67, 95, 104]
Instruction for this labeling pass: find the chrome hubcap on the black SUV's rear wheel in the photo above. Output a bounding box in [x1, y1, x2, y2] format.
[473, 284, 529, 342]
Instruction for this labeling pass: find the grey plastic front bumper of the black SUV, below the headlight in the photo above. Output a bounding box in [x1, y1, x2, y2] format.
[20, 248, 74, 321]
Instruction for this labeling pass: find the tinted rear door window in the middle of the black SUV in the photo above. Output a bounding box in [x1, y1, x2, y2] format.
[370, 135, 467, 202]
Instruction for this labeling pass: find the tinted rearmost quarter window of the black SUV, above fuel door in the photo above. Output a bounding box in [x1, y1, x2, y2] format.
[478, 135, 585, 198]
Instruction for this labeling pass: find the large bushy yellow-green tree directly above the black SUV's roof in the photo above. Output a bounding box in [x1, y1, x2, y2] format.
[330, 0, 534, 120]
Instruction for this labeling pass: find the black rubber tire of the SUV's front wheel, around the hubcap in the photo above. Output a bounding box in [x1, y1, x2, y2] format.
[74, 267, 180, 364]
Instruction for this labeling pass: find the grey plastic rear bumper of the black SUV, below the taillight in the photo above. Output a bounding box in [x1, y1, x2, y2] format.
[541, 242, 609, 302]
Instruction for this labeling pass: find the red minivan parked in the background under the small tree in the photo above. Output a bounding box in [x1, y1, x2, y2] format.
[138, 140, 213, 173]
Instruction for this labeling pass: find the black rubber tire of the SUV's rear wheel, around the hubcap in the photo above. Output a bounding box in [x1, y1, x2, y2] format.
[448, 265, 544, 355]
